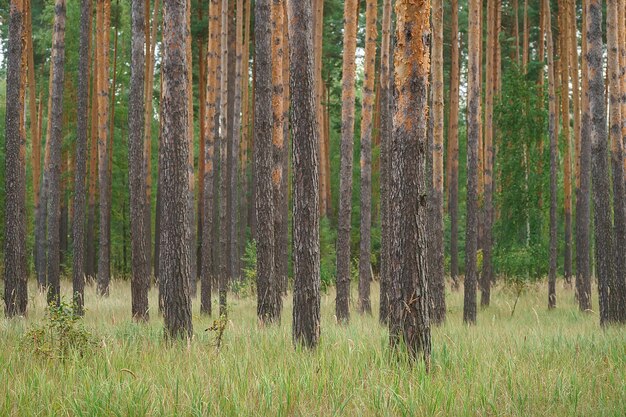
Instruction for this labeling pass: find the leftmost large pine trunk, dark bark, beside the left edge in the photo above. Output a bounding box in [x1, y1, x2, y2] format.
[4, 0, 27, 317]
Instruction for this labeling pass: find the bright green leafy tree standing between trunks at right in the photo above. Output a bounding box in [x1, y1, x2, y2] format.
[494, 65, 550, 278]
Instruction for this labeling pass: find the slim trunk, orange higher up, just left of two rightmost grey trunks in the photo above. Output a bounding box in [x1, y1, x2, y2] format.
[576, 0, 591, 311]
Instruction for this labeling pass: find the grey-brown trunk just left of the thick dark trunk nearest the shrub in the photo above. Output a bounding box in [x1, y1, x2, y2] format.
[128, 0, 150, 321]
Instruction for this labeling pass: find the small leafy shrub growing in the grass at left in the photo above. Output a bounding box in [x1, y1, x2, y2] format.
[21, 299, 98, 361]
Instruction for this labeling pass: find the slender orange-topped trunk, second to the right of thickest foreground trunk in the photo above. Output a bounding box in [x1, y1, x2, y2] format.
[447, 0, 460, 290]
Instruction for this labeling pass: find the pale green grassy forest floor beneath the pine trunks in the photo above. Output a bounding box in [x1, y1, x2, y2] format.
[0, 281, 626, 416]
